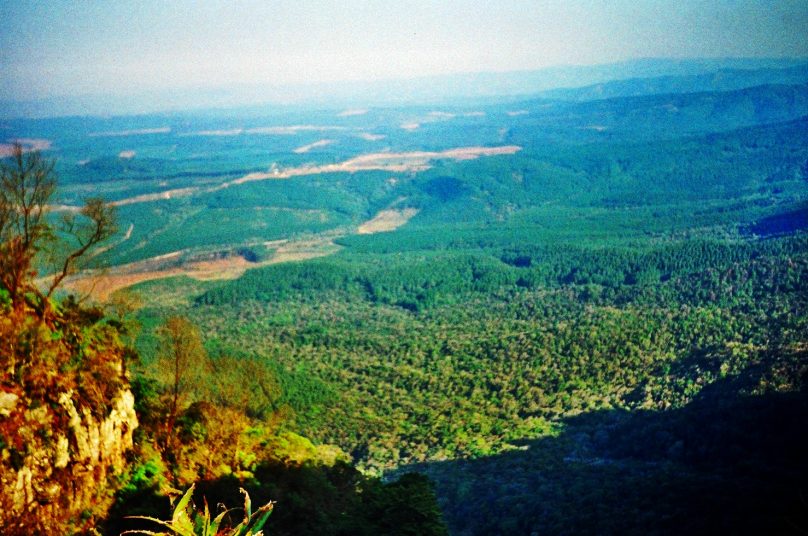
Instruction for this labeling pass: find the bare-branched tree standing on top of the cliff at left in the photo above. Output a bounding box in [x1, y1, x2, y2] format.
[0, 144, 117, 317]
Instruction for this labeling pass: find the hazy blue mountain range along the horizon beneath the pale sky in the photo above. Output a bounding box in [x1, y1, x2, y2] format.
[0, 58, 808, 118]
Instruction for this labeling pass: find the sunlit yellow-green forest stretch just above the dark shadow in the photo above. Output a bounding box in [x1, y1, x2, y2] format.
[148, 237, 808, 474]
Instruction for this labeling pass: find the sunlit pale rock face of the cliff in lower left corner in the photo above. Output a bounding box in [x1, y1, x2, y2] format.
[0, 388, 138, 534]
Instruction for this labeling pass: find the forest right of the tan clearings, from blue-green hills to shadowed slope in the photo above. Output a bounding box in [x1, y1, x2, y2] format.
[128, 82, 808, 534]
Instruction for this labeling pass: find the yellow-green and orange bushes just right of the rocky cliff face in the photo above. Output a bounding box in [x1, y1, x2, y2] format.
[106, 310, 446, 535]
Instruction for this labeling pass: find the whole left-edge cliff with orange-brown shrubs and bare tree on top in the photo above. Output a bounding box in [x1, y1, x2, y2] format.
[0, 146, 138, 534]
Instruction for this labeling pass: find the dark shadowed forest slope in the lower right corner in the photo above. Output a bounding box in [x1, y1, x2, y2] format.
[418, 354, 808, 535]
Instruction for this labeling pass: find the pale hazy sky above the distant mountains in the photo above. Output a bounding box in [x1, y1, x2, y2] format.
[0, 0, 808, 100]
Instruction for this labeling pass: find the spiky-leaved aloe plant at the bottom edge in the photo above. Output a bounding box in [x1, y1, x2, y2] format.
[121, 485, 275, 536]
